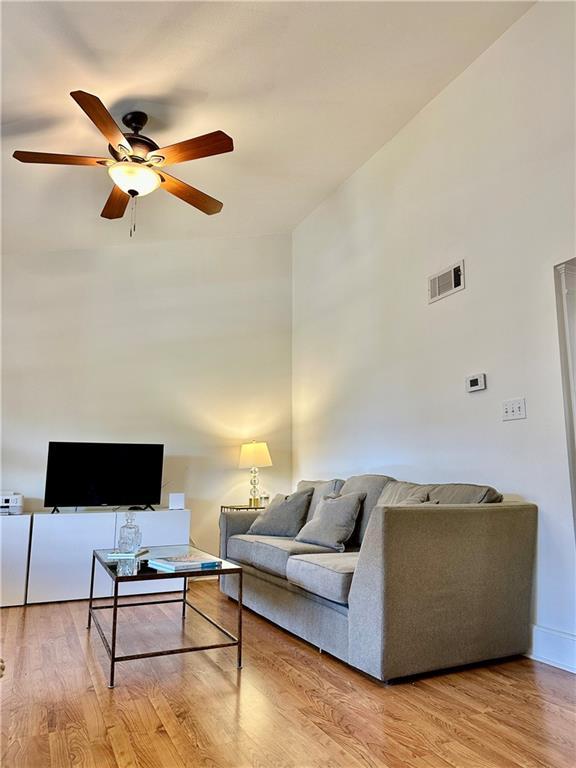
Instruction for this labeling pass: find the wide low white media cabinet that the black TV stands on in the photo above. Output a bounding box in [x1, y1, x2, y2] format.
[25, 509, 190, 604]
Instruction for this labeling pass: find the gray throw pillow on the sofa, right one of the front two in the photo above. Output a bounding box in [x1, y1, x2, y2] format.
[296, 493, 366, 552]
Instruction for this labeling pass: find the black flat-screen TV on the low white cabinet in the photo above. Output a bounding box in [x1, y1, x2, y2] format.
[44, 442, 164, 507]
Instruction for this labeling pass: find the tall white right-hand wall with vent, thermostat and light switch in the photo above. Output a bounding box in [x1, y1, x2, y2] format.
[293, 3, 576, 666]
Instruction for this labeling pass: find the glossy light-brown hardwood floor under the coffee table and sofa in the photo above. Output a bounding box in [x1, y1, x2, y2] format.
[0, 582, 576, 768]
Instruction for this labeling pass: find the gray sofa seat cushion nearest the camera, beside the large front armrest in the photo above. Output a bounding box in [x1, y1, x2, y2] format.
[286, 552, 358, 605]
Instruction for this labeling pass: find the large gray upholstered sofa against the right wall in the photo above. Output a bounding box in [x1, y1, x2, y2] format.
[220, 475, 537, 681]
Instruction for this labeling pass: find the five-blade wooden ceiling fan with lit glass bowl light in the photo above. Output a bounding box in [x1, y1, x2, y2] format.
[13, 91, 234, 219]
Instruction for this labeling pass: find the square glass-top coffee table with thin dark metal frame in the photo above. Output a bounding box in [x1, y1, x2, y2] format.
[87, 544, 242, 688]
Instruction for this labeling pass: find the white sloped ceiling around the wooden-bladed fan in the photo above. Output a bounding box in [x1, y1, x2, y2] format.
[2, 2, 530, 250]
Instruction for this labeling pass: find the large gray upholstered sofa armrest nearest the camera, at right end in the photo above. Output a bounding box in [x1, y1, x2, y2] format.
[349, 503, 537, 680]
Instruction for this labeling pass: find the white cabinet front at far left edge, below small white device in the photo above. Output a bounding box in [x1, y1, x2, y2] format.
[0, 515, 32, 608]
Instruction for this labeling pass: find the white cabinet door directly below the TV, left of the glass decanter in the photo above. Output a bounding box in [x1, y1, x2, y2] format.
[28, 512, 116, 603]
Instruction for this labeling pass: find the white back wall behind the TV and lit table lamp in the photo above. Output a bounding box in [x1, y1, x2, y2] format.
[2, 232, 291, 552]
